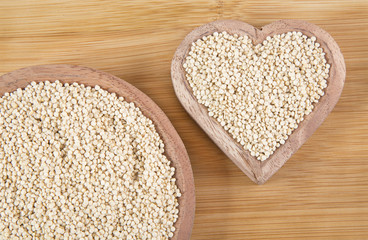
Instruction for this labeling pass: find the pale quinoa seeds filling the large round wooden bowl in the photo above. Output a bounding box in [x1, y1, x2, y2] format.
[0, 81, 180, 240]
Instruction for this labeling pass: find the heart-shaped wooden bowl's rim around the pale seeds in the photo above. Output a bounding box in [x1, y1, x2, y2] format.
[171, 20, 346, 184]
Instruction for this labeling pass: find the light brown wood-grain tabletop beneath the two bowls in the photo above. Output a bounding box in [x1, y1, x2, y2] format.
[0, 0, 368, 239]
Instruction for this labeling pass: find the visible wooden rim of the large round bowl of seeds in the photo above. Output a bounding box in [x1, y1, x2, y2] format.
[0, 65, 195, 240]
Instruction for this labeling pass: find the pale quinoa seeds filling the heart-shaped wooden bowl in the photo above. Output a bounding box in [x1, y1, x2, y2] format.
[183, 32, 330, 161]
